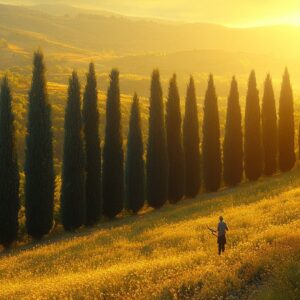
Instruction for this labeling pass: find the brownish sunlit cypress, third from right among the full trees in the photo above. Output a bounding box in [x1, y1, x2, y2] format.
[244, 71, 262, 181]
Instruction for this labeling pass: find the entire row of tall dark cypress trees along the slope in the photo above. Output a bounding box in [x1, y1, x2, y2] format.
[0, 51, 295, 246]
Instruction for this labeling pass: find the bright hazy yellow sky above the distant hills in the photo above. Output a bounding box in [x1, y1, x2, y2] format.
[0, 0, 300, 26]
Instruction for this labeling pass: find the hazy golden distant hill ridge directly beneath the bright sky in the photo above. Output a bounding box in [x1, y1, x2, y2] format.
[0, 5, 300, 57]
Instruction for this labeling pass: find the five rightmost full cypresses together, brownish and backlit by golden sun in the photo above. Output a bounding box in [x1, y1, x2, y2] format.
[209, 69, 296, 191]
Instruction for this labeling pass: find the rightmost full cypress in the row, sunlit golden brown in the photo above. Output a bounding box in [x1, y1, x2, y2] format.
[278, 69, 296, 172]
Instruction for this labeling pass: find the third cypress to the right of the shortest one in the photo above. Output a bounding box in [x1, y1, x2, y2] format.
[183, 76, 201, 198]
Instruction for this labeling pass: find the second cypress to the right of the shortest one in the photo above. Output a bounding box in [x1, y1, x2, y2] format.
[166, 74, 185, 203]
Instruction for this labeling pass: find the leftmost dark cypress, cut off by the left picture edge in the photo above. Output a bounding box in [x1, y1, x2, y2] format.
[0, 77, 19, 247]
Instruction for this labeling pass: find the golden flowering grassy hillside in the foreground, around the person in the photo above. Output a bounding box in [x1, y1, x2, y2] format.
[0, 168, 300, 299]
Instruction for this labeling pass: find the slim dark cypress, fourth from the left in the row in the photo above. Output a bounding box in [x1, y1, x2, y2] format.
[83, 63, 102, 225]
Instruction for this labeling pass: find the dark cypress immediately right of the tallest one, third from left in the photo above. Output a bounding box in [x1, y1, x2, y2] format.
[61, 72, 85, 231]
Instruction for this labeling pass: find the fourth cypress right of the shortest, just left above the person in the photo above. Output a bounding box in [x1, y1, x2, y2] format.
[202, 75, 222, 192]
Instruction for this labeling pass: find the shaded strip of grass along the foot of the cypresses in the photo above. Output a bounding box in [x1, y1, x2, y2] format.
[0, 168, 300, 258]
